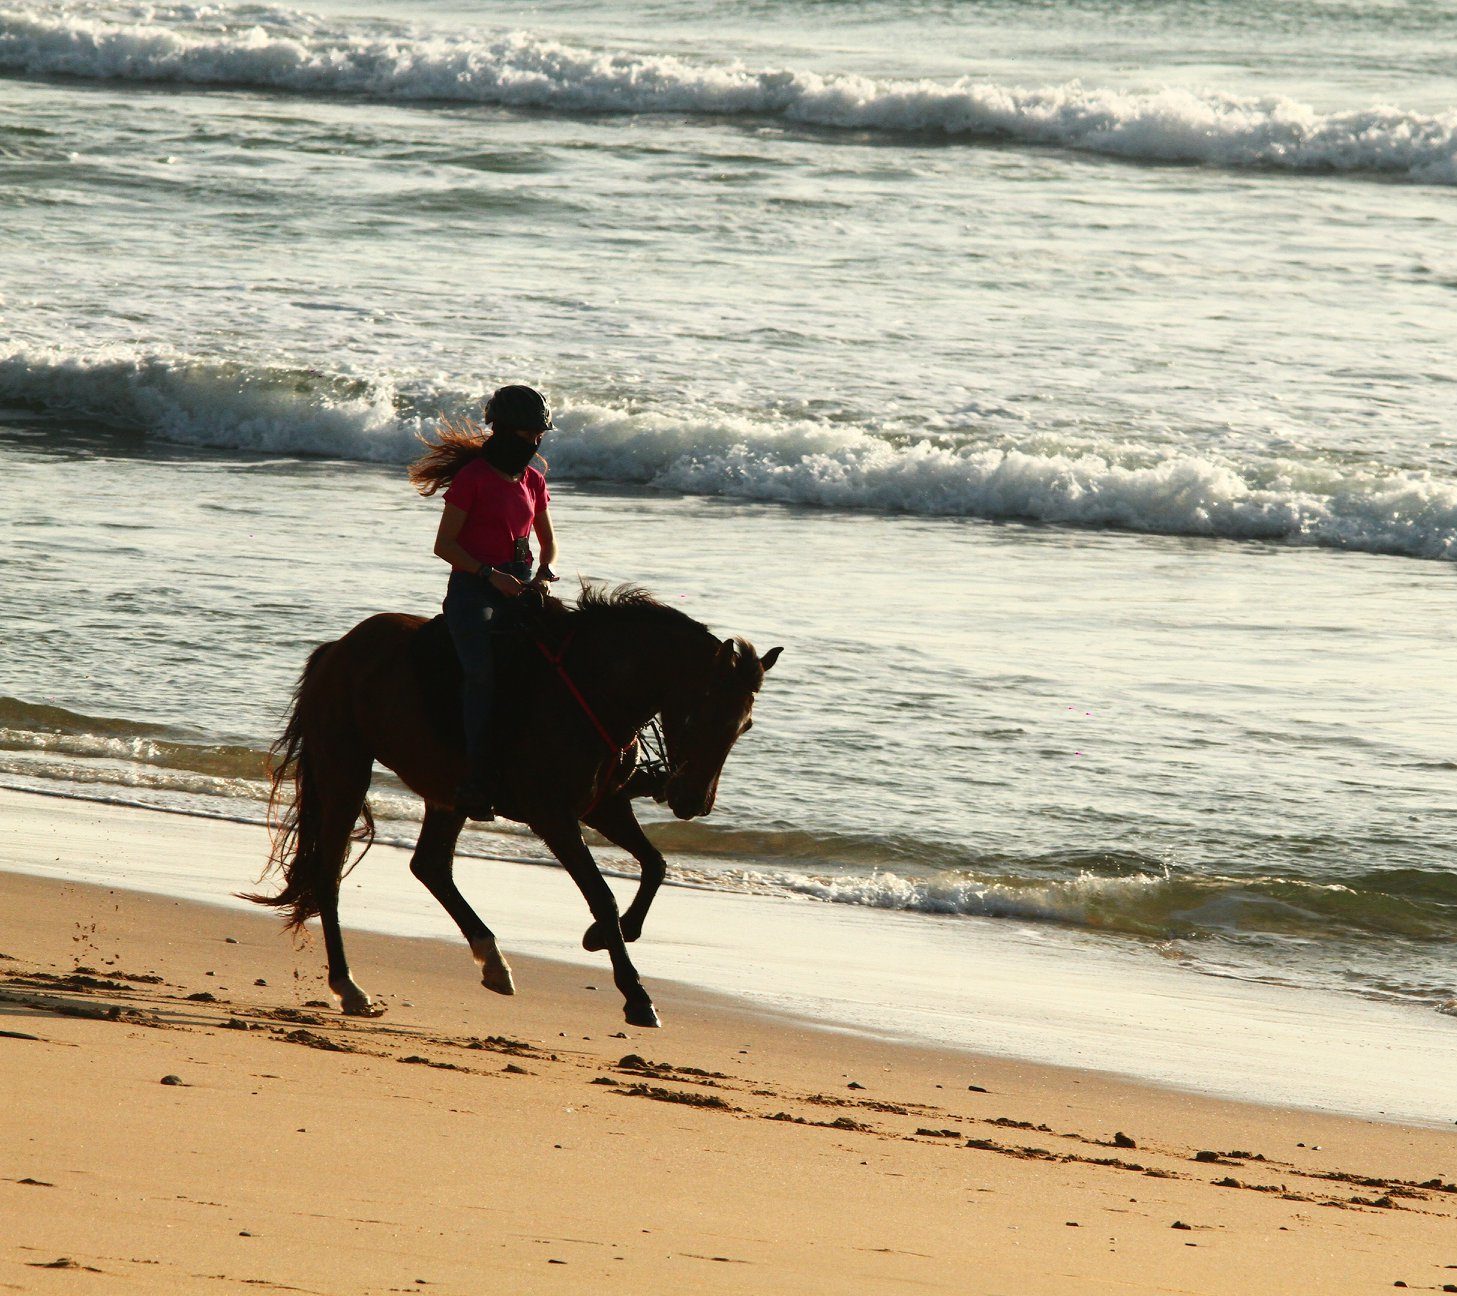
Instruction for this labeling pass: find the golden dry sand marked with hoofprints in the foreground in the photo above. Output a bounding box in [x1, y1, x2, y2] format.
[0, 816, 1457, 1296]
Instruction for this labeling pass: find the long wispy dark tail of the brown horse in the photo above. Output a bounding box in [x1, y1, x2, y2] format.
[239, 643, 374, 930]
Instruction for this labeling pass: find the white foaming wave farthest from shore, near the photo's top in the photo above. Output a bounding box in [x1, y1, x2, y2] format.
[0, 3, 1457, 185]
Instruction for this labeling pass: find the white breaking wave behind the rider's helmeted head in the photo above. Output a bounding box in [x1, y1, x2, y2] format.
[0, 351, 1457, 560]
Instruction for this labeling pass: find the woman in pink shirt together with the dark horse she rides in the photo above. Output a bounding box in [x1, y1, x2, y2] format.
[246, 388, 779, 1026]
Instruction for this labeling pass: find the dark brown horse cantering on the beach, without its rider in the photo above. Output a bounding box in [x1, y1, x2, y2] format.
[242, 585, 781, 1026]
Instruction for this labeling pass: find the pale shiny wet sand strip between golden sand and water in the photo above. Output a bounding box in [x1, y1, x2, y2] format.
[0, 789, 1457, 1128]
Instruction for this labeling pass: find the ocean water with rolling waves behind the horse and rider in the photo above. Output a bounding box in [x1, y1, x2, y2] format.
[0, 0, 1457, 1032]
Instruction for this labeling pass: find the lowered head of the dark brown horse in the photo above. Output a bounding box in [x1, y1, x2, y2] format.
[663, 639, 781, 819]
